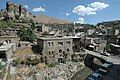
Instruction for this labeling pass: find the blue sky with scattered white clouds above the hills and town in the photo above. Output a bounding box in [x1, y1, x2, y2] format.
[0, 0, 120, 24]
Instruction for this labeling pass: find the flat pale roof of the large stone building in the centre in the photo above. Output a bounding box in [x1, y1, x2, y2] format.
[39, 36, 79, 40]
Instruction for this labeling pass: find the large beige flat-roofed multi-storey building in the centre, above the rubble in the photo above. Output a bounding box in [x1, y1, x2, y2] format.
[37, 36, 78, 63]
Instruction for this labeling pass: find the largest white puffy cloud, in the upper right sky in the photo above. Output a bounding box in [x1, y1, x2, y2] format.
[73, 2, 109, 16]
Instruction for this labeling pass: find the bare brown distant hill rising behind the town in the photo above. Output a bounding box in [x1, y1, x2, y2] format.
[32, 14, 71, 24]
